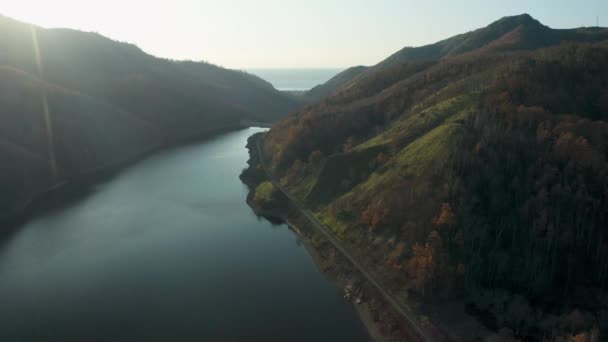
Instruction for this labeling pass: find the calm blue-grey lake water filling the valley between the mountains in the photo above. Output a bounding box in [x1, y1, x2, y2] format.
[0, 129, 369, 341]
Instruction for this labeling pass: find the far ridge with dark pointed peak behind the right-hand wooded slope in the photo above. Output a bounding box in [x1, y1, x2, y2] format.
[309, 14, 608, 100]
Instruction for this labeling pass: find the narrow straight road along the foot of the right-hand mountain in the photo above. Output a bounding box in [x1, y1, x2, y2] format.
[255, 135, 432, 342]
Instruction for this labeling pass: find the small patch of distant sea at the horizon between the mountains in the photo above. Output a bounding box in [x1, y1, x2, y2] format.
[247, 69, 344, 91]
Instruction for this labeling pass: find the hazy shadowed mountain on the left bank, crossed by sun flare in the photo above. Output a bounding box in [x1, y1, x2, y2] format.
[0, 16, 298, 216]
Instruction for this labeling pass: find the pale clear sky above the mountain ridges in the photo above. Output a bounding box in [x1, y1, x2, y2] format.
[0, 0, 608, 69]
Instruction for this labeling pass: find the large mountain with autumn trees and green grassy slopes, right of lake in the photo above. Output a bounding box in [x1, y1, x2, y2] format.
[253, 15, 608, 341]
